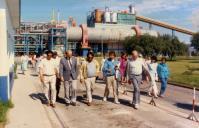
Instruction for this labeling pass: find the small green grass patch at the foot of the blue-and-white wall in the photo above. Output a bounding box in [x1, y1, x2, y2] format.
[0, 101, 13, 128]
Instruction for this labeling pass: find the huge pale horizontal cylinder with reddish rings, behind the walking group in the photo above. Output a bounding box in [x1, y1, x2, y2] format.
[67, 27, 158, 42]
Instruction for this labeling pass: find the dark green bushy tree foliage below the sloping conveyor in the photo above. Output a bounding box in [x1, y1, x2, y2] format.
[124, 35, 188, 59]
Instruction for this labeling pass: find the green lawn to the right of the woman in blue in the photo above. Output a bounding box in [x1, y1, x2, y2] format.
[168, 59, 199, 88]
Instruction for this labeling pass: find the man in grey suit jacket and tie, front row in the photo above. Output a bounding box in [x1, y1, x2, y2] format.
[59, 50, 78, 106]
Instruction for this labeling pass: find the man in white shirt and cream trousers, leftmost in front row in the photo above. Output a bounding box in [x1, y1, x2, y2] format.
[39, 51, 57, 107]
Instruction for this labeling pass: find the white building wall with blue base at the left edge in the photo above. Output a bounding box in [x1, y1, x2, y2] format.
[0, 0, 15, 99]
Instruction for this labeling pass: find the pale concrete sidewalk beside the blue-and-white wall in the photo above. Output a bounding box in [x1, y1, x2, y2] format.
[6, 71, 59, 128]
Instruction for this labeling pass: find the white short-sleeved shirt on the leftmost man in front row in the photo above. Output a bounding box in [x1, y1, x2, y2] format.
[39, 58, 57, 75]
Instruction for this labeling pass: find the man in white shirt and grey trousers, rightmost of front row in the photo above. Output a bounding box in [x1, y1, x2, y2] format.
[126, 50, 144, 109]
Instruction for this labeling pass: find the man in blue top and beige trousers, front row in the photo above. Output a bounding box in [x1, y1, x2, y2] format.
[102, 51, 120, 104]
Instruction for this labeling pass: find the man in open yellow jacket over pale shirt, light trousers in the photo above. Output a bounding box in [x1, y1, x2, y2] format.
[81, 52, 99, 106]
